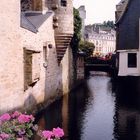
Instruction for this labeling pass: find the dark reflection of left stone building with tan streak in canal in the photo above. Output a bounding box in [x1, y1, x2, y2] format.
[35, 81, 90, 140]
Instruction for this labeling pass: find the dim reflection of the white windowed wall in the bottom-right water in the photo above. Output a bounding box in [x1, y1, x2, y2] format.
[117, 108, 140, 140]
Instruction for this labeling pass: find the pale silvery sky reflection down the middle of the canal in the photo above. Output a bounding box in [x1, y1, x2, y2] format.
[82, 75, 114, 140]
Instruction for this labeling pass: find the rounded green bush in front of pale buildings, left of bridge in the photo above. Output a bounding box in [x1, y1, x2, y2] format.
[79, 40, 95, 57]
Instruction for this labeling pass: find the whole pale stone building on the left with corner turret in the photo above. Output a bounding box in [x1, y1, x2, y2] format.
[0, 0, 73, 114]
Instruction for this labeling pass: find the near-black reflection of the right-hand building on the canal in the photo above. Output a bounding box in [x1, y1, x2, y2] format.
[114, 77, 140, 140]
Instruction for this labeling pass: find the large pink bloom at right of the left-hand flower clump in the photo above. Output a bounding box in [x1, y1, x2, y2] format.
[18, 114, 34, 123]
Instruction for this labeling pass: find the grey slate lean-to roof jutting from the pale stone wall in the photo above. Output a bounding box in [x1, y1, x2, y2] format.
[21, 11, 53, 33]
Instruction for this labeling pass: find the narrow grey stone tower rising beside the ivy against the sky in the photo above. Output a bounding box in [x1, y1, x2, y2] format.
[78, 5, 86, 39]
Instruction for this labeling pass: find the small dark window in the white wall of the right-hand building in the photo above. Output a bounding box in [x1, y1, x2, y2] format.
[128, 53, 137, 68]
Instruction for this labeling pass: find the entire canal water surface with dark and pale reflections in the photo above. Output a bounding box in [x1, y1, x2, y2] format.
[36, 72, 140, 140]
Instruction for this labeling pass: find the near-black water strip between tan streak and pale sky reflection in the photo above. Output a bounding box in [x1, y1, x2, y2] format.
[69, 80, 92, 140]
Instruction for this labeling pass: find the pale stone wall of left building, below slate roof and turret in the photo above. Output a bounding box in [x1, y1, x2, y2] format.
[0, 0, 72, 114]
